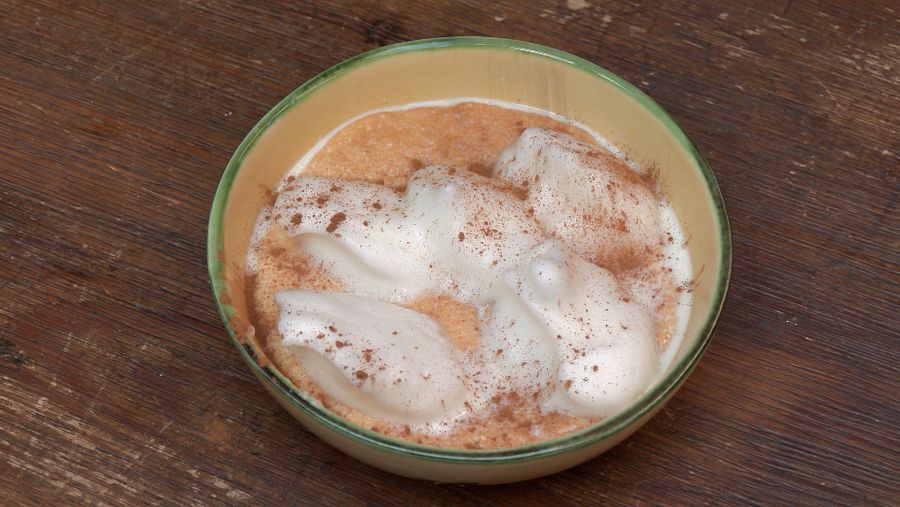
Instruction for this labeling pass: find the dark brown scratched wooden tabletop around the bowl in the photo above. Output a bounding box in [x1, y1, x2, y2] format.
[0, 0, 900, 505]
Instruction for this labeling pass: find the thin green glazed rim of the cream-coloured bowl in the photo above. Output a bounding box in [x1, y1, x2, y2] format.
[207, 37, 732, 464]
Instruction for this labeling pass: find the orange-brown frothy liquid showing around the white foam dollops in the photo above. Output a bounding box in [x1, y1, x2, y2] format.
[247, 103, 680, 449]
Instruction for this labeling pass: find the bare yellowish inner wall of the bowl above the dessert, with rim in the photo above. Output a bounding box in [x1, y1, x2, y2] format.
[209, 38, 730, 462]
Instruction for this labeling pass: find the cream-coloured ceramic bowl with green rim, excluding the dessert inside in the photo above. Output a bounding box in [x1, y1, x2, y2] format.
[208, 37, 731, 484]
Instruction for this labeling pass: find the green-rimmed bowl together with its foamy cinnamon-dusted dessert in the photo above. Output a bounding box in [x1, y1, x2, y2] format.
[209, 38, 730, 483]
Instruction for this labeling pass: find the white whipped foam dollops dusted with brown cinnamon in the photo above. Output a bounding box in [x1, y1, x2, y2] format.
[247, 99, 691, 433]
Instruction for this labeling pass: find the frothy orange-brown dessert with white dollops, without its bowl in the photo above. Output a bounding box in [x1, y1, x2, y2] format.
[247, 99, 691, 448]
